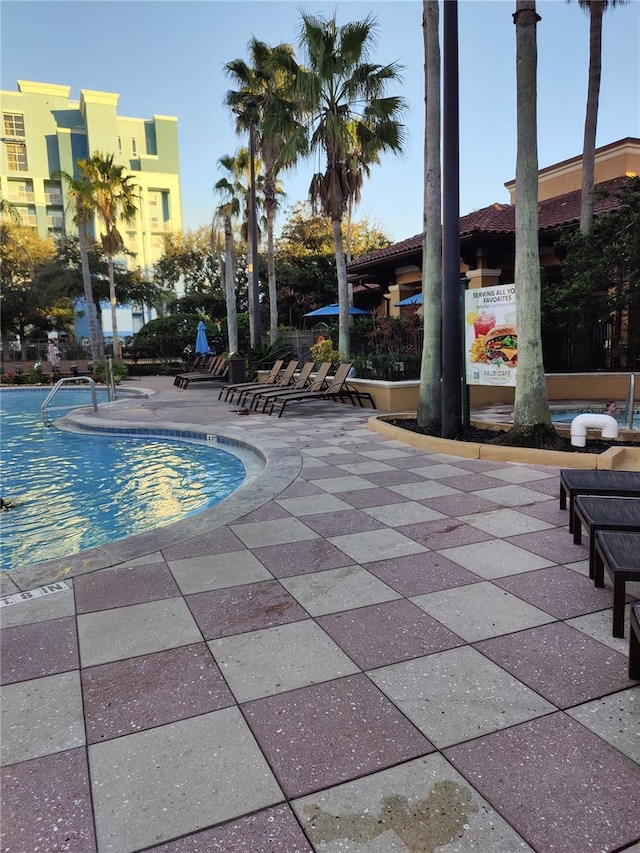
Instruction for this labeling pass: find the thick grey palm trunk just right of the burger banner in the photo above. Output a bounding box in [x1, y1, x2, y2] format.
[502, 0, 559, 449]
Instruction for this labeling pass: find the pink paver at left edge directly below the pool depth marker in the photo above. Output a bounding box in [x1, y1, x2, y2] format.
[0, 605, 79, 684]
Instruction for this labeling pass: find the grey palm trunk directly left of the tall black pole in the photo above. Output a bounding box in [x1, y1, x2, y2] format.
[417, 0, 442, 432]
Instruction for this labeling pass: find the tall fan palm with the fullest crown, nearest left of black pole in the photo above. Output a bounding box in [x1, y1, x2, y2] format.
[288, 13, 406, 357]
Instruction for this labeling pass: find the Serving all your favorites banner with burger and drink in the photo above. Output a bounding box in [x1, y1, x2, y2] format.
[464, 284, 518, 385]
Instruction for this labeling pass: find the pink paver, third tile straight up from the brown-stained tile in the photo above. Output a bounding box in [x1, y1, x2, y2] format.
[185, 581, 308, 640]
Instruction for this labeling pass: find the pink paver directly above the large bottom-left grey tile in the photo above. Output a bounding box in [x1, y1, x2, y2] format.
[81, 643, 234, 743]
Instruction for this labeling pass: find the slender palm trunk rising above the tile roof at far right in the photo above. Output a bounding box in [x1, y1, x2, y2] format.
[578, 0, 626, 235]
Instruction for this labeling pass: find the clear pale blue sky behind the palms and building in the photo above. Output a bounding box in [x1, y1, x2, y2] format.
[0, 0, 640, 240]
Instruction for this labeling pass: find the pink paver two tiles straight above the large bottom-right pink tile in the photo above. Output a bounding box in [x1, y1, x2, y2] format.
[317, 601, 463, 669]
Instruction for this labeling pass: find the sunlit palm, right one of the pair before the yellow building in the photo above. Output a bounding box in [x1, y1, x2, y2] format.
[77, 152, 137, 358]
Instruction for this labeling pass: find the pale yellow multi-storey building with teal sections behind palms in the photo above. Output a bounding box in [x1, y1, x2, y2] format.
[0, 80, 182, 337]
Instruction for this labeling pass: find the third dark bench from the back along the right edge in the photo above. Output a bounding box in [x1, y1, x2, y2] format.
[593, 530, 640, 637]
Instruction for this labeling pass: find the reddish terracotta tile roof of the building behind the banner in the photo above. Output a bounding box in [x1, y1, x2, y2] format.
[347, 177, 627, 272]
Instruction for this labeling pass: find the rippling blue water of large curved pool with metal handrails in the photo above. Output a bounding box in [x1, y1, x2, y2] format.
[0, 388, 246, 570]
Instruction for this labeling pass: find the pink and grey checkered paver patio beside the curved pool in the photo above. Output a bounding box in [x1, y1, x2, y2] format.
[1, 378, 640, 853]
